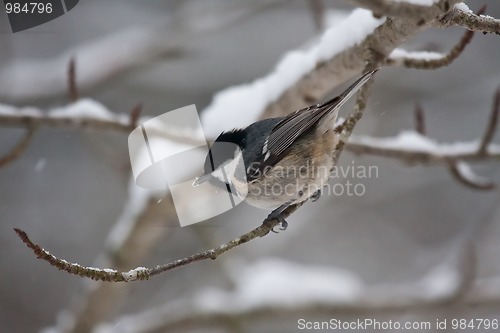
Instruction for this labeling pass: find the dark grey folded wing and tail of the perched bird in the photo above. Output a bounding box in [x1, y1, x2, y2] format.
[262, 70, 377, 167]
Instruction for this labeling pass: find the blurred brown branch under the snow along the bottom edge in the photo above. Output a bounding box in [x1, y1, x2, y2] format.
[104, 277, 500, 333]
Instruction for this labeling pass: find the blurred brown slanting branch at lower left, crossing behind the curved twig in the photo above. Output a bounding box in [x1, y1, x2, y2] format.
[65, 195, 175, 333]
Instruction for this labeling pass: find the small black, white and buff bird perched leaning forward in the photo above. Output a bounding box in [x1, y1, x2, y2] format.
[193, 70, 377, 230]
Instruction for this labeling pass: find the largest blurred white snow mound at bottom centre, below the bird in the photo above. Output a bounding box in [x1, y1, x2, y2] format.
[195, 258, 364, 312]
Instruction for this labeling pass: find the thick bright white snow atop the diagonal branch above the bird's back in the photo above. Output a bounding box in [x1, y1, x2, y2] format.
[202, 9, 384, 137]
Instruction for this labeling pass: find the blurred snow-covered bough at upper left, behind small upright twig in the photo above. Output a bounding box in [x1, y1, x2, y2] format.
[0, 27, 176, 99]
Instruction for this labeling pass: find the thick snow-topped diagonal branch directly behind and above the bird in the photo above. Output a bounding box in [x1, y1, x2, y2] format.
[202, 0, 466, 136]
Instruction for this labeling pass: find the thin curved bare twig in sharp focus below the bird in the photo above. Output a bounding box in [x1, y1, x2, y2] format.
[14, 203, 303, 282]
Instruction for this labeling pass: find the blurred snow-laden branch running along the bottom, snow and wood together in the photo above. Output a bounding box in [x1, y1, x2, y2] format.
[93, 252, 500, 333]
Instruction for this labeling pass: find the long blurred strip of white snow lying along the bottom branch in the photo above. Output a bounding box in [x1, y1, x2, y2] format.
[95, 258, 484, 333]
